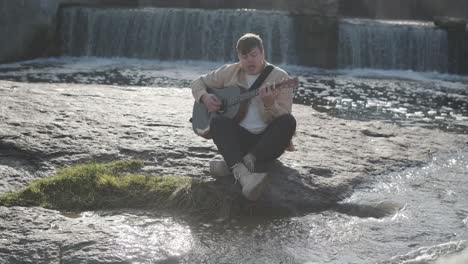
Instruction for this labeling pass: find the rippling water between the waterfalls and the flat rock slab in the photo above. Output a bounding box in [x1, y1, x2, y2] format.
[0, 58, 468, 131]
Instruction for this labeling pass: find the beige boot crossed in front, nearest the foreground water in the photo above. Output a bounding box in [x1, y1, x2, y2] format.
[232, 163, 267, 201]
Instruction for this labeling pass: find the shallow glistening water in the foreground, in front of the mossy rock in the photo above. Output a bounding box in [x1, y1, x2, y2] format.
[64, 151, 468, 264]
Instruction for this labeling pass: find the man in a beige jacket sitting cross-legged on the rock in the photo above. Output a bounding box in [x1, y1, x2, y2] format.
[191, 33, 296, 200]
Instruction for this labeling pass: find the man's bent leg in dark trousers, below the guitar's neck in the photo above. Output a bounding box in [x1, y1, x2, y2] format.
[249, 114, 296, 162]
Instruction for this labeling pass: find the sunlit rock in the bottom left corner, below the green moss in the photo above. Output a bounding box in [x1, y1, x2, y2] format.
[0, 206, 142, 264]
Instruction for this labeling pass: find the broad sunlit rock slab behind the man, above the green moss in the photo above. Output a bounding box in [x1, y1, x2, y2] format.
[0, 81, 462, 212]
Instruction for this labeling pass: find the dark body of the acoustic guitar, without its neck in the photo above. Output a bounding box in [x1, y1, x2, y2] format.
[192, 86, 246, 139]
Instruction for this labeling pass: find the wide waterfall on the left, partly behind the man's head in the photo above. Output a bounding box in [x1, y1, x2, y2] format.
[60, 7, 295, 64]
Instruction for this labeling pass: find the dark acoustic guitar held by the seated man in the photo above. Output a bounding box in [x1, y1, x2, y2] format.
[191, 77, 299, 139]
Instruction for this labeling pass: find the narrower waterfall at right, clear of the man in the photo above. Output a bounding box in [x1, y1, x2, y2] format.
[338, 19, 448, 72]
